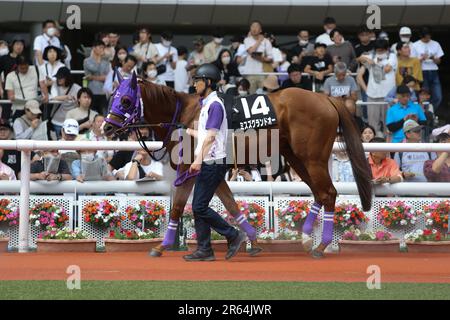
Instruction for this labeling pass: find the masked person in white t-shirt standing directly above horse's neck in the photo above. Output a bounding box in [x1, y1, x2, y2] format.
[156, 31, 178, 88]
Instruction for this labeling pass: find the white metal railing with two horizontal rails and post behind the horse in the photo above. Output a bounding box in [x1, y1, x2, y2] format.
[0, 140, 450, 252]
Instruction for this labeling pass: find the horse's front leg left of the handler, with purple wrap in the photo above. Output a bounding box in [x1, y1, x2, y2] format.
[150, 178, 195, 257]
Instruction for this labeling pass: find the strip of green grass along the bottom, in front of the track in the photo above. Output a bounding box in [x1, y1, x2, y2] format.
[0, 281, 450, 300]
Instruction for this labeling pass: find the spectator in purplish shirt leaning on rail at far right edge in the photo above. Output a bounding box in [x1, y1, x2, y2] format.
[423, 133, 450, 182]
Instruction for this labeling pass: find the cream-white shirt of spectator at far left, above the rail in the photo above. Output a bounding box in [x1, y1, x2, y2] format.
[5, 66, 38, 112]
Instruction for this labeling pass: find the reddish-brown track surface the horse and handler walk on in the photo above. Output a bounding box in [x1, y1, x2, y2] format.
[0, 252, 450, 283]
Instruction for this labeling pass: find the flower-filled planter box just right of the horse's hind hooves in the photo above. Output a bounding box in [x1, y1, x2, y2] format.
[339, 228, 400, 253]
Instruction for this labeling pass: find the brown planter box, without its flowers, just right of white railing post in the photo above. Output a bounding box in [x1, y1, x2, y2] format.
[36, 239, 97, 252]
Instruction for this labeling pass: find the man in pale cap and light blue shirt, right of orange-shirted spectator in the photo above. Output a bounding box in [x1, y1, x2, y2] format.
[394, 119, 431, 182]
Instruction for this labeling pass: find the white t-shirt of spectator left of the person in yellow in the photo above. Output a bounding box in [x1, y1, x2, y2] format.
[365, 53, 397, 98]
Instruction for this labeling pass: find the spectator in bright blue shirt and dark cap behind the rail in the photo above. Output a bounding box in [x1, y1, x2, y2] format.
[386, 85, 427, 142]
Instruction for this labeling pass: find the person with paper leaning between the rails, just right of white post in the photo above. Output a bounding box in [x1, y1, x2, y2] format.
[30, 150, 72, 181]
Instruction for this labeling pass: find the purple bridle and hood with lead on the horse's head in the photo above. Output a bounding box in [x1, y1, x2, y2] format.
[105, 72, 198, 187]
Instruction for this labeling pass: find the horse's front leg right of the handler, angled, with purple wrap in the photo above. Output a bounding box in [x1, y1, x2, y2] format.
[216, 181, 262, 256]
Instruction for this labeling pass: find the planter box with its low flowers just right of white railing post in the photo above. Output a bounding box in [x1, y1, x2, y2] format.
[36, 227, 96, 252]
